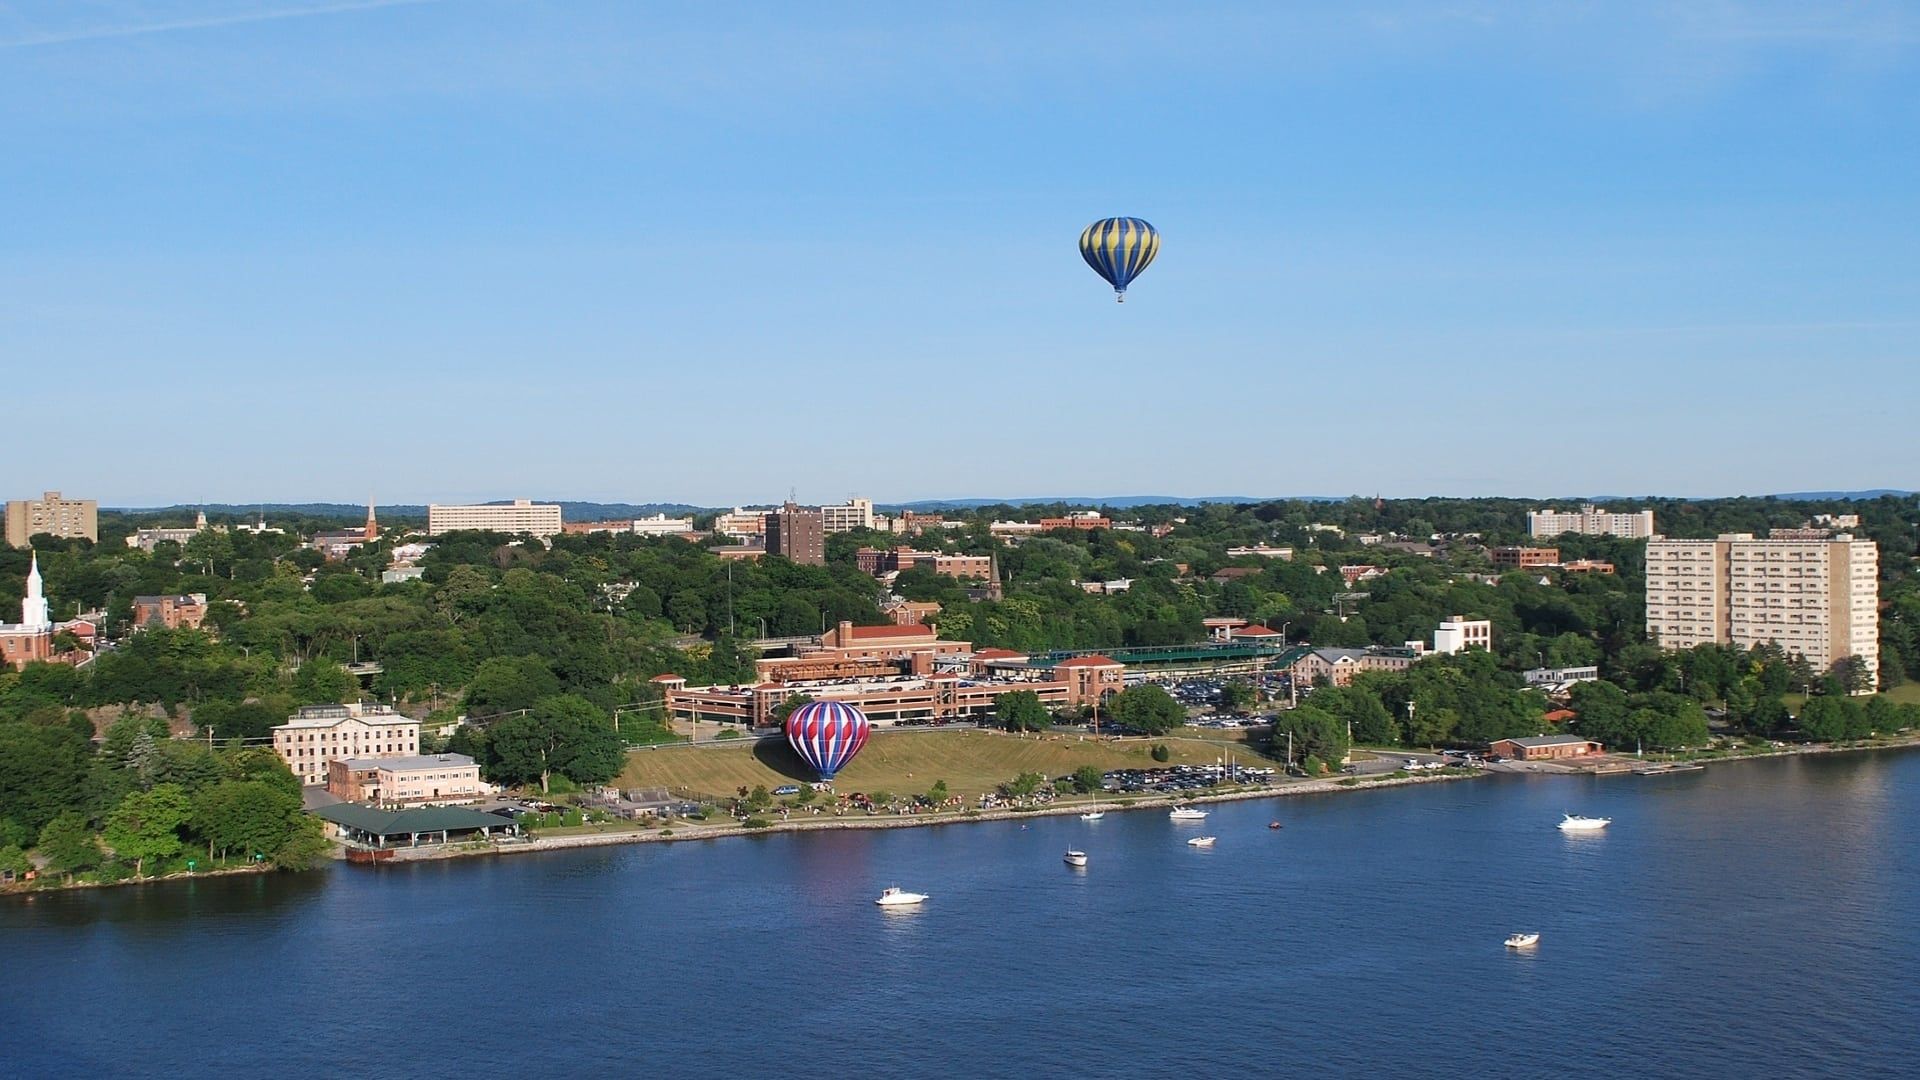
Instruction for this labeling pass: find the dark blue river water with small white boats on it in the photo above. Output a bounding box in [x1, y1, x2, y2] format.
[0, 751, 1920, 1080]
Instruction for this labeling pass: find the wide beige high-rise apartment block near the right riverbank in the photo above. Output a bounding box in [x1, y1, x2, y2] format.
[1647, 530, 1880, 686]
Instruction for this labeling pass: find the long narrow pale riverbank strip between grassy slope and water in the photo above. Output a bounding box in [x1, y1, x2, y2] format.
[374, 769, 1484, 861]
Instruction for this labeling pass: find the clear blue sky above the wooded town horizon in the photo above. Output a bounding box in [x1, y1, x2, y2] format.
[0, 0, 1920, 505]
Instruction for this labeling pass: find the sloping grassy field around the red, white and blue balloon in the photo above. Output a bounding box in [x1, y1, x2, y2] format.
[618, 728, 1267, 799]
